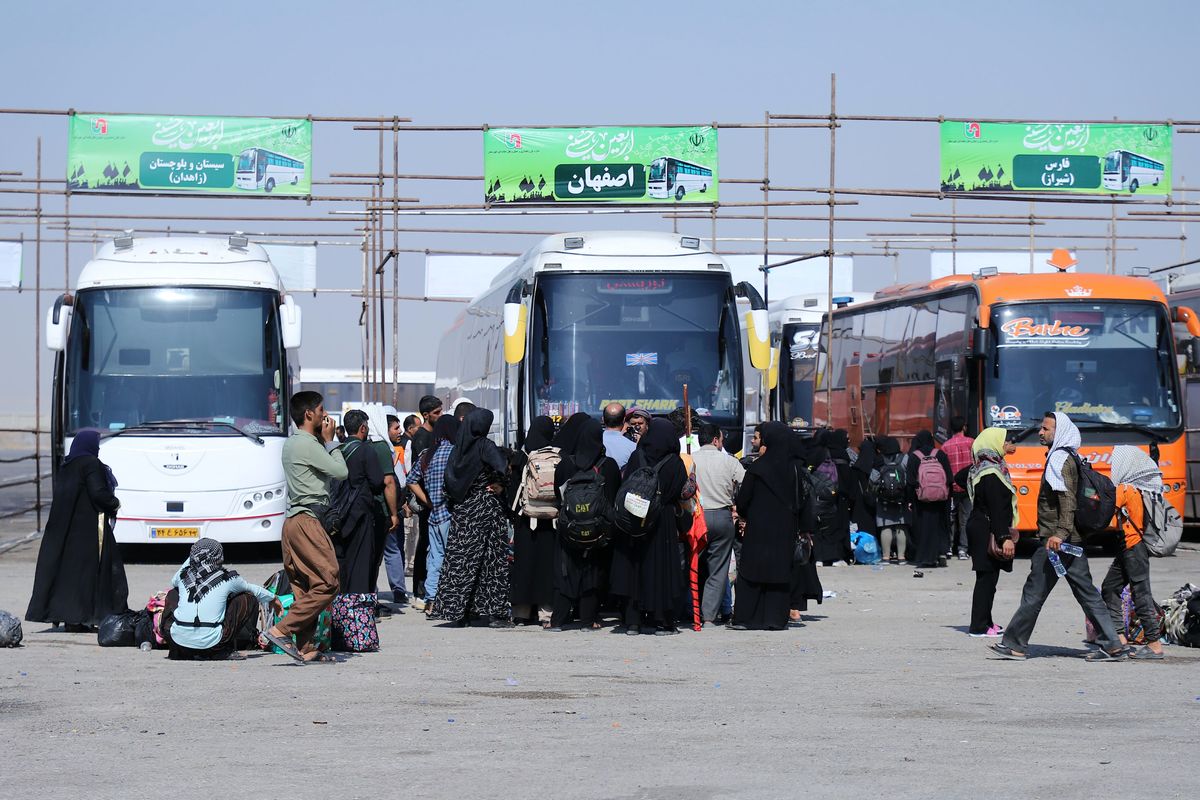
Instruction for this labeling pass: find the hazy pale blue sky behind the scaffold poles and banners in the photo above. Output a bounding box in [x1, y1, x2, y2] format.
[0, 0, 1200, 414]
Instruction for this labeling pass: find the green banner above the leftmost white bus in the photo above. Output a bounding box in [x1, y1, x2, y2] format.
[67, 114, 312, 194]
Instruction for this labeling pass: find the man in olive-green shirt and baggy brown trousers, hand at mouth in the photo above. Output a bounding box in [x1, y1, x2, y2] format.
[264, 392, 348, 661]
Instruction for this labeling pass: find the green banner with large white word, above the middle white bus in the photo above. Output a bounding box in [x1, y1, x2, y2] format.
[484, 126, 718, 203]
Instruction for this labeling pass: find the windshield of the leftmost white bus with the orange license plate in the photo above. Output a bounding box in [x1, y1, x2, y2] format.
[64, 287, 284, 435]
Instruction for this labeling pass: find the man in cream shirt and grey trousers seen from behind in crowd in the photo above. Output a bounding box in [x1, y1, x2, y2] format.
[691, 422, 746, 626]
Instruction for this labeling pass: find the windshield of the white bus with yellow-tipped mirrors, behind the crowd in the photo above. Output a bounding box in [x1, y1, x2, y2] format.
[530, 272, 742, 426]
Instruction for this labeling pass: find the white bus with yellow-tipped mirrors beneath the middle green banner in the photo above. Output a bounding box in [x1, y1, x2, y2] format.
[436, 231, 770, 445]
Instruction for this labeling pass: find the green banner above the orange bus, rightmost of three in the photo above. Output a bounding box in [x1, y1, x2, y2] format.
[941, 120, 1171, 194]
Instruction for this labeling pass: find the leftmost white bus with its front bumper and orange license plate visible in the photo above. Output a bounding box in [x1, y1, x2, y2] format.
[46, 234, 300, 543]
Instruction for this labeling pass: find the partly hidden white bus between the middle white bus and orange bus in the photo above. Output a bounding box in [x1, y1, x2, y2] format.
[768, 291, 875, 428]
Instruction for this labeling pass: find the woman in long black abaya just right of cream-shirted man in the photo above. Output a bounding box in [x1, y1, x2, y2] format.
[730, 422, 802, 631]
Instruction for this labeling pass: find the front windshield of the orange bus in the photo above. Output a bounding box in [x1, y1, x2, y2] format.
[984, 301, 1182, 431]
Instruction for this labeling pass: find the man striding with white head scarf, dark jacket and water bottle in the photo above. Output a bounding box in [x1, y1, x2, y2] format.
[990, 411, 1126, 661]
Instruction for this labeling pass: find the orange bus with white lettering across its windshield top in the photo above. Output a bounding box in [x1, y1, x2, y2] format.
[814, 269, 1200, 531]
